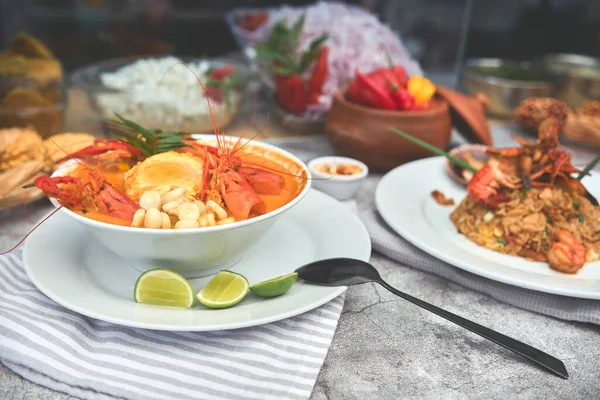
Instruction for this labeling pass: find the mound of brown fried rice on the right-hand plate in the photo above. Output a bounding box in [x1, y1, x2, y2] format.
[450, 187, 600, 262]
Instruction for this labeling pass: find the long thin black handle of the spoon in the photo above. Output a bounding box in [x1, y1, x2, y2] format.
[377, 280, 569, 379]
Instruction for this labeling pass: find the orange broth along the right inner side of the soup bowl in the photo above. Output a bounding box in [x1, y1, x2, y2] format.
[236, 145, 308, 213]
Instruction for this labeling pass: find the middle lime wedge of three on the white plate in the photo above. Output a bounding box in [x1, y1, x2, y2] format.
[196, 270, 250, 308]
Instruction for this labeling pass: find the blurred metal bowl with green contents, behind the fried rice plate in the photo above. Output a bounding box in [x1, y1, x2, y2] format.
[463, 58, 558, 117]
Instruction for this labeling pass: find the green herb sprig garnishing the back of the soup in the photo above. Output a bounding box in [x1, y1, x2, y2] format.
[109, 112, 190, 157]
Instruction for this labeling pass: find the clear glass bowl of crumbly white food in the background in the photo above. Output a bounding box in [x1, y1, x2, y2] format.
[71, 56, 248, 133]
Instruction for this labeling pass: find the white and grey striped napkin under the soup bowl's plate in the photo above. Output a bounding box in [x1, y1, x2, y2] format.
[0, 247, 344, 400]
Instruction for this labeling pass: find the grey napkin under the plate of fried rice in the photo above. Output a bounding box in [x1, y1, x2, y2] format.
[359, 210, 600, 325]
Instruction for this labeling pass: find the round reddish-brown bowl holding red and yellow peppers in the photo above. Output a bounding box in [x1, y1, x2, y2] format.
[325, 88, 452, 171]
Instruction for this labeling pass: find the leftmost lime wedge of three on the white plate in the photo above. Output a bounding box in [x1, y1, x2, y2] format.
[133, 268, 194, 308]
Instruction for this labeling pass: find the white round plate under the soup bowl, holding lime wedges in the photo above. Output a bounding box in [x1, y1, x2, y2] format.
[23, 190, 371, 331]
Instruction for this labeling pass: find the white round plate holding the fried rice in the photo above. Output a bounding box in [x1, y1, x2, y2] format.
[375, 157, 600, 299]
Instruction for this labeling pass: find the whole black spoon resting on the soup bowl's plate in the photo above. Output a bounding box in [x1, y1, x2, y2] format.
[296, 258, 569, 379]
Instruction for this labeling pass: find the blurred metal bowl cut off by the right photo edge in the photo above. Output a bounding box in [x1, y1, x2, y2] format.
[543, 54, 600, 108]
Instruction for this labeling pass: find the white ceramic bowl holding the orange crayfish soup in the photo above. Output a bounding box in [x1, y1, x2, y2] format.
[50, 135, 311, 278]
